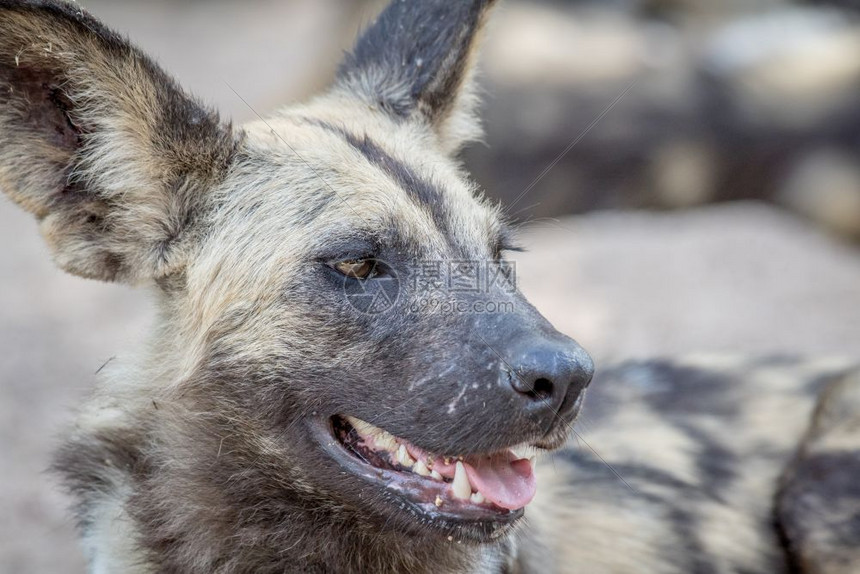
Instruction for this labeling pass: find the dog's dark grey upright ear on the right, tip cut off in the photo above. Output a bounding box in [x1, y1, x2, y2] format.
[337, 0, 495, 153]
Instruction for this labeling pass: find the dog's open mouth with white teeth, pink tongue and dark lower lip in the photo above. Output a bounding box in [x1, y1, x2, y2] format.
[312, 416, 537, 535]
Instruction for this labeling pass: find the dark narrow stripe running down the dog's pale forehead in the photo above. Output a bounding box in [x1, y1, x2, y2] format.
[304, 120, 449, 236]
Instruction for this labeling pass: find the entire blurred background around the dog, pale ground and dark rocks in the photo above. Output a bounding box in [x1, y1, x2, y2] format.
[0, 0, 860, 574]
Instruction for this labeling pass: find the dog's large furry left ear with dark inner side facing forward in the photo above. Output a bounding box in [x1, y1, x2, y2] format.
[0, 0, 233, 282]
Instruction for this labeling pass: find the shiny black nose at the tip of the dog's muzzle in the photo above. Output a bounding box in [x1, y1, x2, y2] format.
[503, 338, 594, 416]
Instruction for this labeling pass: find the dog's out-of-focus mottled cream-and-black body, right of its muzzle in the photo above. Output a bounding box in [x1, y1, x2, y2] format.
[529, 356, 860, 574]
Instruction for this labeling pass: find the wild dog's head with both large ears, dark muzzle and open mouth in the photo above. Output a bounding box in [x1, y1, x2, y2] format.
[0, 0, 592, 563]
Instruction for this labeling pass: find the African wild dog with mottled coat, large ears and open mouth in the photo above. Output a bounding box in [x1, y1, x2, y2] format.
[0, 0, 860, 574]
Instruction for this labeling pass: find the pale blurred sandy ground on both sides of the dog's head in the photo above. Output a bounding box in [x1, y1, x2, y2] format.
[0, 197, 860, 574]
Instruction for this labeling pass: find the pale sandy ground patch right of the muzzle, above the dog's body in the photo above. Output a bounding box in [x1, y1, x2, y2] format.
[518, 202, 860, 361]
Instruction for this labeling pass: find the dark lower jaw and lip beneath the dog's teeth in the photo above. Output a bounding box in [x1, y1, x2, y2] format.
[307, 418, 524, 543]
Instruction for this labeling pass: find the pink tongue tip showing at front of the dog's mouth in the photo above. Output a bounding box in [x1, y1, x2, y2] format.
[464, 452, 537, 510]
